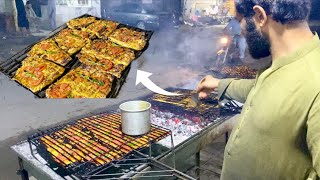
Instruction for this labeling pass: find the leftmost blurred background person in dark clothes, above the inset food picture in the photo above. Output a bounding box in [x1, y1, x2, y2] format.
[15, 0, 30, 36]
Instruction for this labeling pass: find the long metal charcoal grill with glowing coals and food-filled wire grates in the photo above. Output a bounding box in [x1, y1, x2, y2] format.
[12, 89, 239, 179]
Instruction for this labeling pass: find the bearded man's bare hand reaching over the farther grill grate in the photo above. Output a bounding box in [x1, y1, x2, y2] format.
[197, 76, 220, 99]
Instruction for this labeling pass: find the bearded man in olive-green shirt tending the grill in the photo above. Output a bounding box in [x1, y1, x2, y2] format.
[197, 0, 320, 180]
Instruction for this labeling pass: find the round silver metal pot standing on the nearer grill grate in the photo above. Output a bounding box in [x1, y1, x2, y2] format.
[119, 101, 151, 136]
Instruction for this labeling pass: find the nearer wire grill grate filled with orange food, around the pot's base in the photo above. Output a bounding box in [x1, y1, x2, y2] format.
[28, 113, 171, 177]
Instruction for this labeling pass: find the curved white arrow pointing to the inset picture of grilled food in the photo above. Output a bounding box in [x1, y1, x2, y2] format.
[136, 70, 181, 96]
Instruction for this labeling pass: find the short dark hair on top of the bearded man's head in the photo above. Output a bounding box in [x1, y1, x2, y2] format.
[236, 0, 311, 24]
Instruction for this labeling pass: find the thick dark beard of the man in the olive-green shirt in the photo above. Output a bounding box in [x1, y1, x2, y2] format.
[245, 18, 271, 59]
